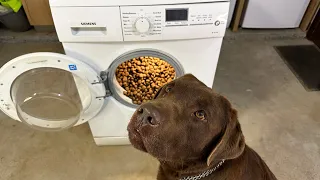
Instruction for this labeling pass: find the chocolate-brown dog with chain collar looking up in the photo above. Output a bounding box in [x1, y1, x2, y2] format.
[128, 75, 276, 180]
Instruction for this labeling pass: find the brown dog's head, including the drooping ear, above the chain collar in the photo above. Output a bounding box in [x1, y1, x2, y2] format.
[128, 74, 245, 165]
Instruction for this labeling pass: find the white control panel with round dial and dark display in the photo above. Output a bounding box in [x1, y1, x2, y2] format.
[120, 2, 229, 41]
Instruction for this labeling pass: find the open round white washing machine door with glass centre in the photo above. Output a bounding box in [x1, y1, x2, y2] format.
[0, 53, 106, 131]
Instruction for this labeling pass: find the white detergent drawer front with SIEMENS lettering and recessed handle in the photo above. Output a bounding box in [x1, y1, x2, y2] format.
[51, 7, 123, 42]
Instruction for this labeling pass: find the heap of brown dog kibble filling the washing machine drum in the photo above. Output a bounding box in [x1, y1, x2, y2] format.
[116, 56, 176, 105]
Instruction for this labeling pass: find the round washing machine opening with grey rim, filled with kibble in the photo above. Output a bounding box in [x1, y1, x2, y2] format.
[108, 49, 184, 108]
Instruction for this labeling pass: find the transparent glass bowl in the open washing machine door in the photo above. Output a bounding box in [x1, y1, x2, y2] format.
[11, 67, 91, 131]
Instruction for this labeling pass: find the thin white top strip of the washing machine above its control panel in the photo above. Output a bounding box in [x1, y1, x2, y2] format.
[50, 0, 230, 7]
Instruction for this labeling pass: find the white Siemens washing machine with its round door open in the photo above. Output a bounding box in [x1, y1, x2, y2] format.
[0, 0, 229, 145]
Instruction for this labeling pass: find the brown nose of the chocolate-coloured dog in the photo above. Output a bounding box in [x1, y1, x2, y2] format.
[137, 104, 160, 127]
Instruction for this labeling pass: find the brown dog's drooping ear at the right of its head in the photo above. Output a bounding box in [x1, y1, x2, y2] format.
[207, 96, 245, 166]
